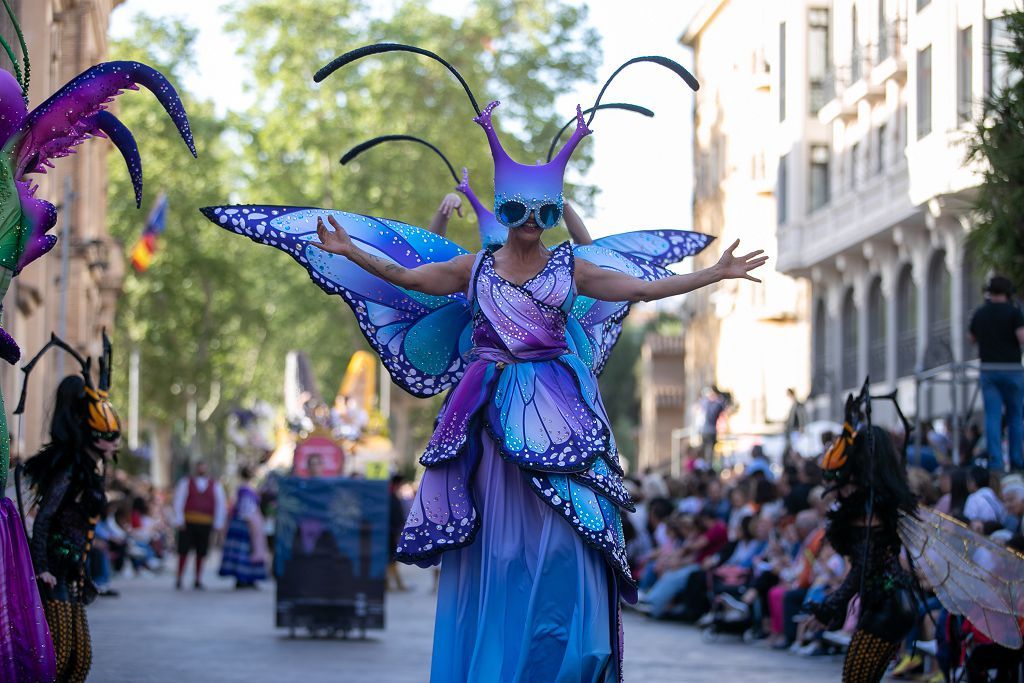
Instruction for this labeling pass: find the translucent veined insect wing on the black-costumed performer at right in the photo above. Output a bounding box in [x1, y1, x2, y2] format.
[899, 507, 1024, 649]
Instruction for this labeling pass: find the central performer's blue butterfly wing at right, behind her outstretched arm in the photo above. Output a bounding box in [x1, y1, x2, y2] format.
[566, 243, 672, 375]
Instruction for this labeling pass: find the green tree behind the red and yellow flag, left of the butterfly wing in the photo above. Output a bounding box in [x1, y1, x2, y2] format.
[109, 17, 290, 464]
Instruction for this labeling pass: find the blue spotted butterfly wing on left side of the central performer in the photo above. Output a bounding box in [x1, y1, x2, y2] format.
[202, 205, 470, 396]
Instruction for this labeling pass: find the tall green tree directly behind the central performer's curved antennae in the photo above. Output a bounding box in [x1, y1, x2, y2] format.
[227, 0, 599, 464]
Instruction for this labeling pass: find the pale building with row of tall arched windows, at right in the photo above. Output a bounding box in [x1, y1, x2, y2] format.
[766, 0, 1014, 432]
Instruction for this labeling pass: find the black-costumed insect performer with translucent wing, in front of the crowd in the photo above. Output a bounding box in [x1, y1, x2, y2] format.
[809, 381, 1024, 683]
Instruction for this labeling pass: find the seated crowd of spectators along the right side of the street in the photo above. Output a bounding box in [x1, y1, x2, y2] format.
[624, 446, 1024, 681]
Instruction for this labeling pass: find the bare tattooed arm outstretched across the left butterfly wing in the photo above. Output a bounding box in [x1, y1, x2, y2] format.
[310, 216, 474, 296]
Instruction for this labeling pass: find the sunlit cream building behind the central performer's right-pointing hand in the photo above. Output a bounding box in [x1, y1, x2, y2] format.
[681, 0, 810, 452]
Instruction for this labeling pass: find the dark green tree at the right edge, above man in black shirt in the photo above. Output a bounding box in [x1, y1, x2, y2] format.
[969, 11, 1024, 289]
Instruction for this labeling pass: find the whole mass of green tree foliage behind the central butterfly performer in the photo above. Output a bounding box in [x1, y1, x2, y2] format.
[110, 0, 600, 462]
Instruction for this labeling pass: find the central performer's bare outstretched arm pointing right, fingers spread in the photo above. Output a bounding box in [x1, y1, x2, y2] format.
[575, 240, 768, 301]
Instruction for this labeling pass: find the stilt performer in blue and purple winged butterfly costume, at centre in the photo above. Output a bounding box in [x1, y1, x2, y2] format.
[203, 44, 764, 682]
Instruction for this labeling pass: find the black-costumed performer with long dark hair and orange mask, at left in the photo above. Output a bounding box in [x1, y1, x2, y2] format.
[15, 334, 121, 683]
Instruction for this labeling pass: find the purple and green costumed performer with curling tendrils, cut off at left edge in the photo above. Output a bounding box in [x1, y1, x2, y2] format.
[0, 0, 196, 681]
